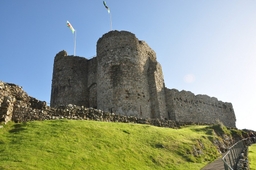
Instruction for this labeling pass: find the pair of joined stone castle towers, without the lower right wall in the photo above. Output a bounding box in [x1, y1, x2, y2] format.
[51, 31, 167, 118]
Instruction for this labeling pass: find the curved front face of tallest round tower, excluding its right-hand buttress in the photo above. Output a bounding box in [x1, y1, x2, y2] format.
[97, 31, 153, 118]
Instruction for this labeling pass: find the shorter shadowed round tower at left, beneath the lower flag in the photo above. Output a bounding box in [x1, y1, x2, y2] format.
[50, 51, 88, 107]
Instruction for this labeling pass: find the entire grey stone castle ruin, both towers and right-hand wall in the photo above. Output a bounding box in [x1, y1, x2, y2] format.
[50, 31, 236, 127]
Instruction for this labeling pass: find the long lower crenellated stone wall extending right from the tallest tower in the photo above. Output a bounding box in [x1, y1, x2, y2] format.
[165, 88, 236, 127]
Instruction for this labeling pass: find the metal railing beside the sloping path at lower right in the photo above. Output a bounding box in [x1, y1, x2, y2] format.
[222, 138, 250, 170]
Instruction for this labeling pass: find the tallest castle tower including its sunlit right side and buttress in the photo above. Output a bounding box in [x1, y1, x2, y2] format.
[97, 31, 166, 118]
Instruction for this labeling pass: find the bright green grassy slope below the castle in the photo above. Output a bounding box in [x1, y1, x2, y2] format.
[0, 120, 243, 170]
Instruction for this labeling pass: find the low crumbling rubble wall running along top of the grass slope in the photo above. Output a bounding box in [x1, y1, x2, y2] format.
[0, 81, 206, 128]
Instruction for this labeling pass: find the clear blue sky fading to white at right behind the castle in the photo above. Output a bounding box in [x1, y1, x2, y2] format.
[0, 0, 256, 130]
